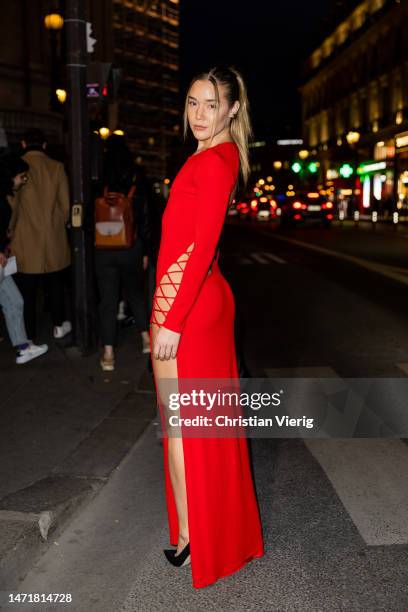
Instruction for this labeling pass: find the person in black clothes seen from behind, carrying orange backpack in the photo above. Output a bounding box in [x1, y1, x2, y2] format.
[95, 137, 151, 371]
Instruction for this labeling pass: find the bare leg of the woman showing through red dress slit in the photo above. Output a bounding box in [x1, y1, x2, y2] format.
[152, 323, 189, 554]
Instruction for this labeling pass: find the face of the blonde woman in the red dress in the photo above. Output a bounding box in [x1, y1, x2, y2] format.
[187, 80, 239, 144]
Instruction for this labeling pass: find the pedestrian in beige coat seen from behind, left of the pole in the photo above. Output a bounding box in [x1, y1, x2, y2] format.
[11, 130, 71, 339]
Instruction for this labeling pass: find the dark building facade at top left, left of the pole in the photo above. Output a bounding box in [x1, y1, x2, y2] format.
[0, 0, 63, 147]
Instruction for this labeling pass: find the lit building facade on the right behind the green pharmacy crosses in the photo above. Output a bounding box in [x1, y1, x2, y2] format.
[300, 0, 408, 212]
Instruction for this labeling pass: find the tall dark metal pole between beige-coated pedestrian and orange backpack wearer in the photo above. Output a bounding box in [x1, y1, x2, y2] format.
[65, 0, 95, 353]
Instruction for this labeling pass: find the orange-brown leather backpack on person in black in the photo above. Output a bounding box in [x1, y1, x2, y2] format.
[95, 185, 136, 249]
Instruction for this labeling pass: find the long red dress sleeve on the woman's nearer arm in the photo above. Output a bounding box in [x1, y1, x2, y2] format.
[154, 149, 236, 333]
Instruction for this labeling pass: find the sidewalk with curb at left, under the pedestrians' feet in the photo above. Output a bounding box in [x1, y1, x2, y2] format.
[0, 315, 156, 591]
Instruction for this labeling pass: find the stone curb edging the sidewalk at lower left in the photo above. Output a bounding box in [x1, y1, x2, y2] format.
[0, 390, 156, 592]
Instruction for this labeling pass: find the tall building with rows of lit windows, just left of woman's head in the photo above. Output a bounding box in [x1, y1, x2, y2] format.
[108, 0, 180, 178]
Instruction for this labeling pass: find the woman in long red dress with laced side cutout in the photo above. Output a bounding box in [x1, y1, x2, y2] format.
[150, 68, 264, 588]
